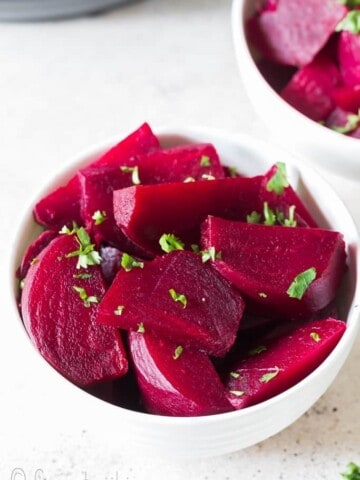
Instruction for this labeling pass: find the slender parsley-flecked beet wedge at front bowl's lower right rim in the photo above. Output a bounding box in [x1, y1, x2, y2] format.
[226, 318, 346, 409]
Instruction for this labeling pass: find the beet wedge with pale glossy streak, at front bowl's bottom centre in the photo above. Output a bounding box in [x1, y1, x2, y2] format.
[129, 331, 233, 416]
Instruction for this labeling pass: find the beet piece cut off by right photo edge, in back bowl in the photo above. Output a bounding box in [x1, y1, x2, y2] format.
[338, 31, 360, 87]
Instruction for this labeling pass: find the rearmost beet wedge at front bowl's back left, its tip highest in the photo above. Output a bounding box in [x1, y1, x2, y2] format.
[34, 123, 159, 230]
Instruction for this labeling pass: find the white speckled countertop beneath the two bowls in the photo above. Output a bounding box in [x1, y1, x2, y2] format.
[0, 0, 360, 480]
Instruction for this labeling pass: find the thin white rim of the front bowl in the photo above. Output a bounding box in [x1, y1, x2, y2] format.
[8, 126, 360, 427]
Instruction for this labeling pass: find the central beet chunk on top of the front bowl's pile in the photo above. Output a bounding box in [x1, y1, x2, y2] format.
[97, 251, 244, 356]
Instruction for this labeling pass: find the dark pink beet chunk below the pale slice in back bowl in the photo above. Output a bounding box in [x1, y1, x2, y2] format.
[281, 53, 341, 122]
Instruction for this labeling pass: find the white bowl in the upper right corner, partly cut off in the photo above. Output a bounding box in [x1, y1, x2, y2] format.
[232, 0, 360, 179]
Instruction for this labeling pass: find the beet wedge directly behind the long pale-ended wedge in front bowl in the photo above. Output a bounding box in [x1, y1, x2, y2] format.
[78, 144, 224, 249]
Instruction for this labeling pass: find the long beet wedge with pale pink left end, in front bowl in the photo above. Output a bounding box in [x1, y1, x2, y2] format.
[114, 176, 263, 254]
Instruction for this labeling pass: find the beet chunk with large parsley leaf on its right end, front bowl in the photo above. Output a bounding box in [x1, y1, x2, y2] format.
[202, 217, 346, 318]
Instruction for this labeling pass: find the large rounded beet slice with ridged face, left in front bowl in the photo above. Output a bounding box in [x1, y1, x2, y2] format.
[21, 235, 128, 386]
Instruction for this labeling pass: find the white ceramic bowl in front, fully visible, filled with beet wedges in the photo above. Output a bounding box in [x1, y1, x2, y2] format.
[6, 128, 360, 457]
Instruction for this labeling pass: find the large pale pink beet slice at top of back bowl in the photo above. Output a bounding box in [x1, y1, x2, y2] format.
[247, 0, 347, 67]
